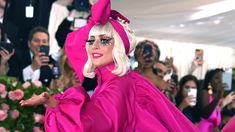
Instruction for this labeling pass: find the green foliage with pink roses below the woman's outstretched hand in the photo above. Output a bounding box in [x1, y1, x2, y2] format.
[0, 76, 61, 132]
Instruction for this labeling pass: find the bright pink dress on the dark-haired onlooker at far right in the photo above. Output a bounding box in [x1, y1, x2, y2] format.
[199, 96, 221, 132]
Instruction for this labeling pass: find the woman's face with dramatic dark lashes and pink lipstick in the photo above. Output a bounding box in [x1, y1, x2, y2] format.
[88, 34, 114, 67]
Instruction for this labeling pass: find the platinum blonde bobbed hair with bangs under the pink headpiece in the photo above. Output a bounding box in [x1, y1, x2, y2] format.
[83, 22, 136, 78]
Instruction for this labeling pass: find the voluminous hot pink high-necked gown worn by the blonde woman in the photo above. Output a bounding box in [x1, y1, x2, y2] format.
[45, 63, 198, 132]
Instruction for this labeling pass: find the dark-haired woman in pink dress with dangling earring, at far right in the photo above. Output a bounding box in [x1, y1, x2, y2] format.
[198, 69, 224, 132]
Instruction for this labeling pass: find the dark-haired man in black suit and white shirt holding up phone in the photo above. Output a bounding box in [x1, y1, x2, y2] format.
[23, 27, 56, 86]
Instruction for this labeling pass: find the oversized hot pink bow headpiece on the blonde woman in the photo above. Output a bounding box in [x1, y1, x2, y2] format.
[65, 0, 130, 83]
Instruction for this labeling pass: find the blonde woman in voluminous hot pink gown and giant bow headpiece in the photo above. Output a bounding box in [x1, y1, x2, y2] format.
[21, 0, 197, 132]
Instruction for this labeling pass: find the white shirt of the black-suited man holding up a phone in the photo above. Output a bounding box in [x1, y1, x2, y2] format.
[23, 52, 40, 81]
